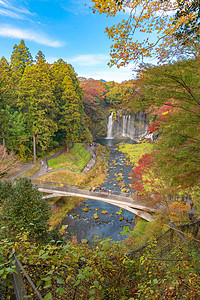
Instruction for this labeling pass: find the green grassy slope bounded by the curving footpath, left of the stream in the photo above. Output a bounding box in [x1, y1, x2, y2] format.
[48, 143, 90, 172]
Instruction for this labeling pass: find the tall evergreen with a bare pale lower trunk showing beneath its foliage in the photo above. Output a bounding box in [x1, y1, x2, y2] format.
[18, 52, 57, 163]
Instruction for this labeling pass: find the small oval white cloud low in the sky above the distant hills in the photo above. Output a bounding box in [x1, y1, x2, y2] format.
[69, 54, 109, 67]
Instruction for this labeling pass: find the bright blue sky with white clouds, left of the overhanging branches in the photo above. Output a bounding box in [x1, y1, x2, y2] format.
[0, 0, 140, 82]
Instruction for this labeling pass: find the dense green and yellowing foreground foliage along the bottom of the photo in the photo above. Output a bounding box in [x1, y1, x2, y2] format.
[0, 227, 200, 300]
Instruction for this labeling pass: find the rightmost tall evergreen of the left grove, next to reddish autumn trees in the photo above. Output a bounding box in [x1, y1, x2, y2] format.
[51, 59, 84, 149]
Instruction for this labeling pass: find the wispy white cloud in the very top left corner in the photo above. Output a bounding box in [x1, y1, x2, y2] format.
[0, 0, 33, 19]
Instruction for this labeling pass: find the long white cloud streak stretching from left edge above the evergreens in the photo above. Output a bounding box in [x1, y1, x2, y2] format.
[0, 24, 64, 48]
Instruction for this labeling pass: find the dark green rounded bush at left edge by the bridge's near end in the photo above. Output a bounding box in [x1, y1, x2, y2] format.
[0, 178, 50, 242]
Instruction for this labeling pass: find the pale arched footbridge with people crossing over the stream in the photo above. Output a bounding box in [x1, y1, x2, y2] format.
[33, 181, 156, 222]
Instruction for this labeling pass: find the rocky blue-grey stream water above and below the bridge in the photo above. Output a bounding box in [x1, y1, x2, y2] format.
[61, 140, 135, 243]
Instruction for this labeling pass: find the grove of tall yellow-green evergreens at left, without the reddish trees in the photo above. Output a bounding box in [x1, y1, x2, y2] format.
[0, 40, 93, 163]
